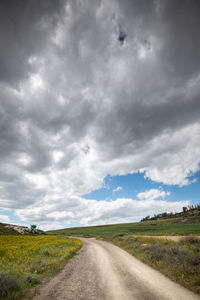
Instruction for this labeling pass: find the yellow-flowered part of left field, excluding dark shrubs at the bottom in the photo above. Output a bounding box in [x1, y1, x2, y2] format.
[0, 235, 82, 281]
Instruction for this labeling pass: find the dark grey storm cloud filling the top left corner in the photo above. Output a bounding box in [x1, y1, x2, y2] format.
[0, 0, 64, 86]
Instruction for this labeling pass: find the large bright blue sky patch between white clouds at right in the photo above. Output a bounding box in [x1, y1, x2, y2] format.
[82, 172, 200, 204]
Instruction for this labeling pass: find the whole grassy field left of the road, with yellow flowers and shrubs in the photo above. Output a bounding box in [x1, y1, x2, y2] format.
[0, 235, 82, 299]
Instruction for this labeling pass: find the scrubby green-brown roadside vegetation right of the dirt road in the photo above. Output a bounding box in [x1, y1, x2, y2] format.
[104, 234, 200, 294]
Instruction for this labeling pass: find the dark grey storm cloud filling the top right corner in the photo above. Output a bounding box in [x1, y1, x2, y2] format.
[119, 0, 200, 80]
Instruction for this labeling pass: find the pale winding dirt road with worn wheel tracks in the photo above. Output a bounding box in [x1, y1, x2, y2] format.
[34, 239, 200, 300]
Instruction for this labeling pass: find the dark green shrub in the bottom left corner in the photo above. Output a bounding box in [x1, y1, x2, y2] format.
[0, 273, 20, 299]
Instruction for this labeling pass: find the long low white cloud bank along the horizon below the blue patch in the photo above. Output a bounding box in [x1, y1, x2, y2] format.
[17, 198, 190, 229]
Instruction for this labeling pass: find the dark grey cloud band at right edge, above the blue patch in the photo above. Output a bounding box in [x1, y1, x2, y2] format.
[95, 83, 200, 157]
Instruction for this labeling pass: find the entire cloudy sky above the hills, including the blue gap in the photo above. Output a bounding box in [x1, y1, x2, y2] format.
[0, 0, 200, 230]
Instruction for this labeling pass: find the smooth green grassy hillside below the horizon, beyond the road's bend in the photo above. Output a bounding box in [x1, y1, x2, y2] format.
[48, 216, 200, 237]
